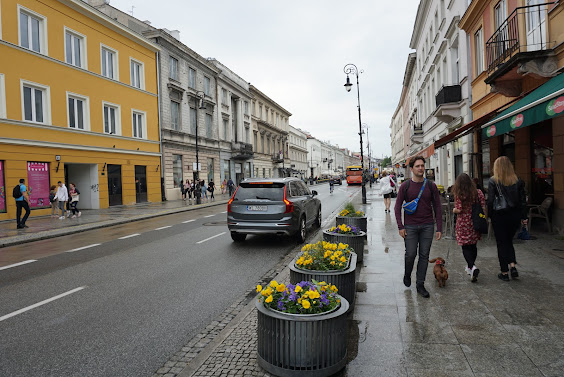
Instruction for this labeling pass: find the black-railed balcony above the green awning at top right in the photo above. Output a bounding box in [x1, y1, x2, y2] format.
[484, 2, 558, 97]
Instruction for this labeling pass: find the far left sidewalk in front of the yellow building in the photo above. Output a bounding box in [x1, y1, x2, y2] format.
[0, 194, 229, 248]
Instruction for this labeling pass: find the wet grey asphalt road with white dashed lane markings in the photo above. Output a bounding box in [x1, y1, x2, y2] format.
[0, 185, 359, 377]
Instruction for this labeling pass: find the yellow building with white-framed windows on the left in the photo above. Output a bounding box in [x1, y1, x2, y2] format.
[0, 0, 161, 220]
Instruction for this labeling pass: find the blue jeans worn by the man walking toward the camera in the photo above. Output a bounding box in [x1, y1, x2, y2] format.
[404, 224, 435, 285]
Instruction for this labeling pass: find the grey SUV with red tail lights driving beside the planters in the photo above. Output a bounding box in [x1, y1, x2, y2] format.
[227, 178, 321, 243]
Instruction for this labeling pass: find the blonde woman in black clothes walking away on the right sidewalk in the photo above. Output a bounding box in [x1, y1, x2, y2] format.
[488, 156, 527, 281]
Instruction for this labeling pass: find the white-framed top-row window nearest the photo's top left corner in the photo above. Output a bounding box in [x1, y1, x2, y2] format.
[18, 5, 47, 54]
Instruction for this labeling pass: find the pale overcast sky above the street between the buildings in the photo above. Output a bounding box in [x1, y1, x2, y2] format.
[110, 0, 419, 158]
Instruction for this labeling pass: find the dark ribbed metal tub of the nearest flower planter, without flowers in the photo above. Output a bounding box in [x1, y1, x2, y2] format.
[256, 297, 349, 377]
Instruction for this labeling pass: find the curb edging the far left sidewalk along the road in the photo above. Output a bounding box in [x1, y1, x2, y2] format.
[0, 201, 227, 249]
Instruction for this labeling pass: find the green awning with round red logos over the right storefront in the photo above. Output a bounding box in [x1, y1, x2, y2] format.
[482, 73, 564, 139]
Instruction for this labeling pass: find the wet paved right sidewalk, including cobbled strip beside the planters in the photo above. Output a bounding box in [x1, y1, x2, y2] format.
[161, 187, 564, 377]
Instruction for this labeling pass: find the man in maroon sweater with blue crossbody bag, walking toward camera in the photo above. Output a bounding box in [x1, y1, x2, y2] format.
[394, 156, 443, 298]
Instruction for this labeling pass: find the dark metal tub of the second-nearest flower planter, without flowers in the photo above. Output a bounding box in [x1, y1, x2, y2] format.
[290, 253, 357, 311]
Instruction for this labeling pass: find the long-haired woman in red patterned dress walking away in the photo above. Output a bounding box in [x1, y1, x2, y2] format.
[452, 173, 486, 283]
